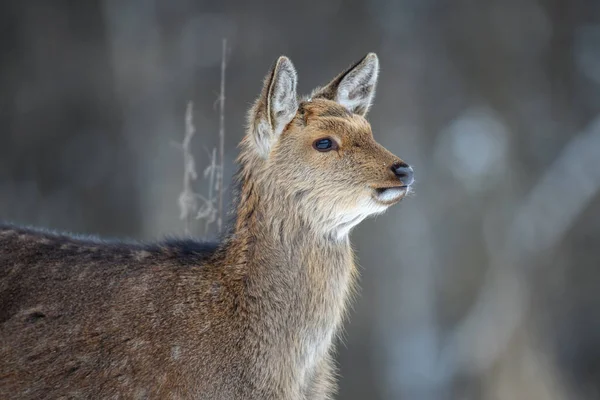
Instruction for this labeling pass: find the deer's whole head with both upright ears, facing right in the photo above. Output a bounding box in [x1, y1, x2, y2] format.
[245, 54, 413, 239]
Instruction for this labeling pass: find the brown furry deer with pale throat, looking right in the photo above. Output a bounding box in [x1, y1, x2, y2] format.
[0, 53, 414, 400]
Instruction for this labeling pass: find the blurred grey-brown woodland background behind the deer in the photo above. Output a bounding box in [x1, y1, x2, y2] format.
[0, 0, 600, 400]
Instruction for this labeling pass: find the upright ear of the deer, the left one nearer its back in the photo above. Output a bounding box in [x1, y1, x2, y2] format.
[249, 56, 298, 158]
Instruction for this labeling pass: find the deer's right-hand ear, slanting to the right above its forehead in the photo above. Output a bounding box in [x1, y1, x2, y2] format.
[312, 53, 379, 116]
